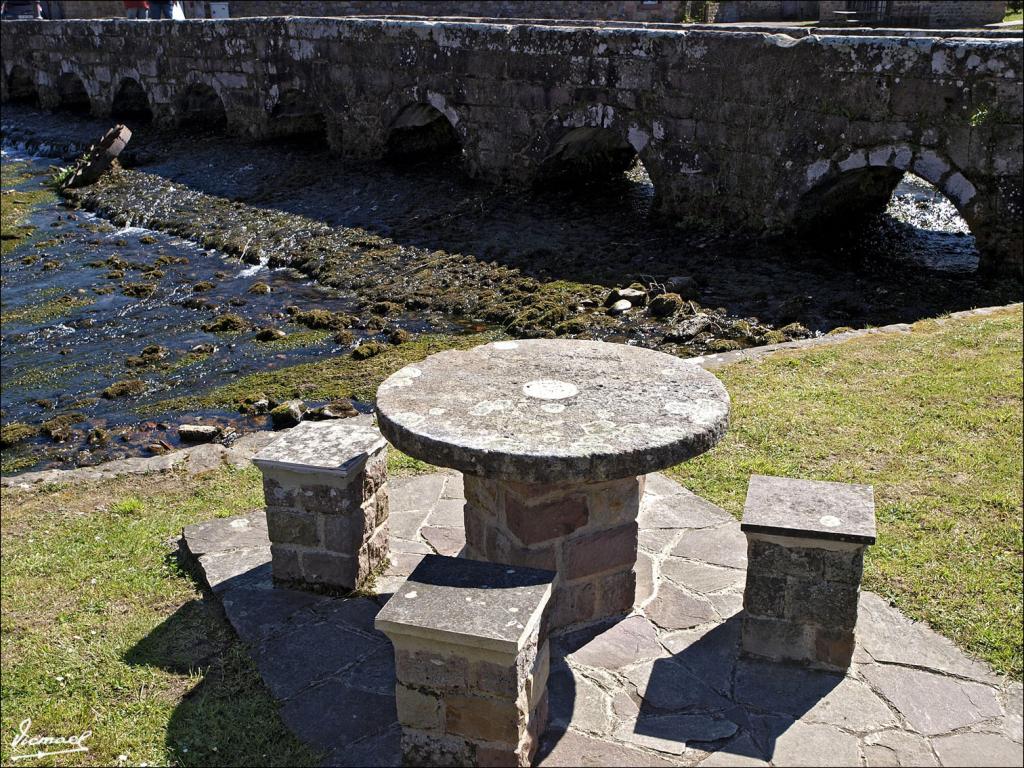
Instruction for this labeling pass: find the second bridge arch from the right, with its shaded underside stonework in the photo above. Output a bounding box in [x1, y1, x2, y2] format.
[531, 104, 660, 196]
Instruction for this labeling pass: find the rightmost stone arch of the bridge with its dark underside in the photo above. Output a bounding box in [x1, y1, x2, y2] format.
[794, 143, 985, 240]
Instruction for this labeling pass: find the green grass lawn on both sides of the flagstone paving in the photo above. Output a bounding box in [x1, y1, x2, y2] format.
[0, 307, 1022, 765]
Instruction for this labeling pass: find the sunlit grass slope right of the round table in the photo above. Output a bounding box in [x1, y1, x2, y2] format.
[672, 307, 1022, 678]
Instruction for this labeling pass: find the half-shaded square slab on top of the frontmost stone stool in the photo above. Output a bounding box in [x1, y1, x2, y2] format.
[375, 555, 555, 653]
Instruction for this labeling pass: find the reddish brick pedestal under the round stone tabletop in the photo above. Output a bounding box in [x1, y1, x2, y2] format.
[464, 474, 644, 630]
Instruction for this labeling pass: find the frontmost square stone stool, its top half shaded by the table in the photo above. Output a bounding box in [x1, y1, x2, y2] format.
[376, 555, 555, 766]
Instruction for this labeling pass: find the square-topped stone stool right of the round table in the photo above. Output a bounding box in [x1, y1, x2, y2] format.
[740, 475, 874, 670]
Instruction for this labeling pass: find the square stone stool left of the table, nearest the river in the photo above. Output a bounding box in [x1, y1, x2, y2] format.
[253, 416, 388, 592]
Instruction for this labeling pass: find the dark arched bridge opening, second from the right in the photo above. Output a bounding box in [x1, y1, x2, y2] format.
[538, 126, 654, 208]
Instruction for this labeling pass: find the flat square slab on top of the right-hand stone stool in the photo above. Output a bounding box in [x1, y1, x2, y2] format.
[739, 475, 876, 544]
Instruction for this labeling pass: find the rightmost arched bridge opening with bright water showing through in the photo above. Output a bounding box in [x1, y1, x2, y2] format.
[797, 166, 979, 271]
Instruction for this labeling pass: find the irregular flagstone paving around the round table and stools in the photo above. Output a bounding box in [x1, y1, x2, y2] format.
[182, 473, 1024, 766]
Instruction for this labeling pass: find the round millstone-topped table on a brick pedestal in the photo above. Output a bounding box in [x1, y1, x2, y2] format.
[377, 340, 729, 629]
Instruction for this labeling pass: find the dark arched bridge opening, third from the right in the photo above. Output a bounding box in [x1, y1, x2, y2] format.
[384, 98, 467, 158]
